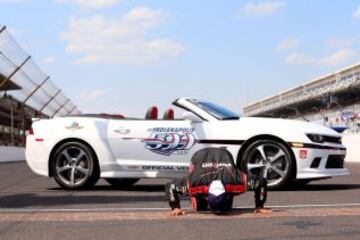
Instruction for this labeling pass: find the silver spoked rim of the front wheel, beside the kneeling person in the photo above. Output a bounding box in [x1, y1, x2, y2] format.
[247, 143, 290, 186]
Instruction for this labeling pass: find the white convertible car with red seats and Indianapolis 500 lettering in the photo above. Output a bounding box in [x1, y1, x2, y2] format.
[26, 98, 349, 189]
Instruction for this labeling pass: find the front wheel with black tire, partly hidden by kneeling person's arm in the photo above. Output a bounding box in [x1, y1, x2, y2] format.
[241, 140, 296, 189]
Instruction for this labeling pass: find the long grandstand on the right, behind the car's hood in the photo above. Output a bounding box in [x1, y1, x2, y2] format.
[243, 63, 360, 133]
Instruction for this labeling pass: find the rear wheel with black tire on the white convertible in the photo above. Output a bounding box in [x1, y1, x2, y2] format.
[50, 141, 100, 189]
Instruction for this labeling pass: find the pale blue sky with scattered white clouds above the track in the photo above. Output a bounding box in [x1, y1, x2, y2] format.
[0, 0, 360, 116]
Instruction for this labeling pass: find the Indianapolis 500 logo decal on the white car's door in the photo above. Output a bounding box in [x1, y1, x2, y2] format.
[123, 127, 197, 156]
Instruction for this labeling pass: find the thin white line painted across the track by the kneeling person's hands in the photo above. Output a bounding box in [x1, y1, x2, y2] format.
[0, 203, 360, 213]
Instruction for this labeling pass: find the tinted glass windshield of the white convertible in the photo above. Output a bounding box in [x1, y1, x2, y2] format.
[188, 99, 240, 120]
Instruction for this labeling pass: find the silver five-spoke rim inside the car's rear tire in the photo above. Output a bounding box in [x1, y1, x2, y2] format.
[56, 146, 91, 187]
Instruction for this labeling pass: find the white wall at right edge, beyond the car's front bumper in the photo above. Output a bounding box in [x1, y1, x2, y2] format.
[342, 133, 360, 163]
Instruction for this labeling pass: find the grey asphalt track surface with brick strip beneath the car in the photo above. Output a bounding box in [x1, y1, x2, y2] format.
[0, 162, 360, 240]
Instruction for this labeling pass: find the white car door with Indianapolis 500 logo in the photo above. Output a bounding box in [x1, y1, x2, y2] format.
[108, 119, 211, 172]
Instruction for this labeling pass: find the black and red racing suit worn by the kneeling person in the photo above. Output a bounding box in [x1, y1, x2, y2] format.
[165, 148, 267, 210]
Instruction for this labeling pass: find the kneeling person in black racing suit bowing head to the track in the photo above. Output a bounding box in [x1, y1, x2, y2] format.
[165, 148, 270, 216]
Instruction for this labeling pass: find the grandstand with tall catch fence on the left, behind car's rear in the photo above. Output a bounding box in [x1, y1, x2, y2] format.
[0, 25, 80, 148]
